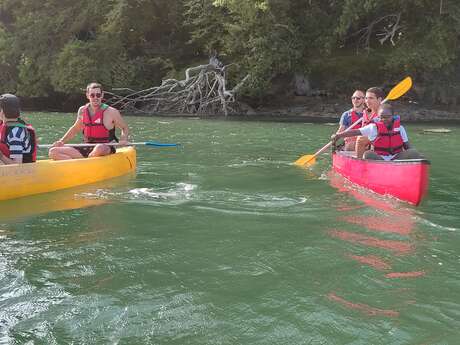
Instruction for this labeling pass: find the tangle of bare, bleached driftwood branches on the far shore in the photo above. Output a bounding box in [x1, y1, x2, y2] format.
[105, 57, 249, 116]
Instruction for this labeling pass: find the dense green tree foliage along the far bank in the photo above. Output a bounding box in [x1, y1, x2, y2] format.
[0, 0, 460, 104]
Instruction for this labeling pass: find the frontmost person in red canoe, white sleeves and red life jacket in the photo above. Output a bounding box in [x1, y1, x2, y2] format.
[331, 104, 423, 161]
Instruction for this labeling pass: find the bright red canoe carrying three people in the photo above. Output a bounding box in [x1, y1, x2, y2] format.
[332, 151, 430, 205]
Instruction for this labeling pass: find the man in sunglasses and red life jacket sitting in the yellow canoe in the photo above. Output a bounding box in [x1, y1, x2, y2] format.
[49, 83, 129, 160]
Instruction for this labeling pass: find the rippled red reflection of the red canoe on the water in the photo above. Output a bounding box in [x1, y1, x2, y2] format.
[327, 172, 425, 317]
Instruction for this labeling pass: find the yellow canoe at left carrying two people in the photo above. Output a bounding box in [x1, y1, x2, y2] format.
[0, 146, 136, 200]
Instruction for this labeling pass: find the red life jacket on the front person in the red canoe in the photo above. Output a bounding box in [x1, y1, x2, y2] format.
[372, 116, 404, 156]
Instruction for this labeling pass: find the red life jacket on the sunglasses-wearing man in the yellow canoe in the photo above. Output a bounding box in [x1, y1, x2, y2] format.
[82, 103, 116, 143]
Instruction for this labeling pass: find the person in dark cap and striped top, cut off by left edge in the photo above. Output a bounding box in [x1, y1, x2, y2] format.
[0, 93, 37, 165]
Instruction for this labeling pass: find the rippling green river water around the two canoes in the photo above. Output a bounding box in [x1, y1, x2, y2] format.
[0, 114, 460, 345]
